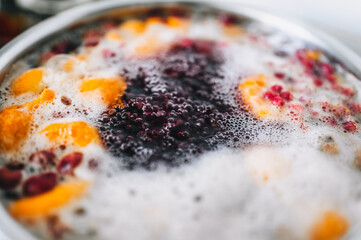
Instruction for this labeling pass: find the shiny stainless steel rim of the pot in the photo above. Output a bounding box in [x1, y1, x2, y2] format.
[0, 0, 361, 240]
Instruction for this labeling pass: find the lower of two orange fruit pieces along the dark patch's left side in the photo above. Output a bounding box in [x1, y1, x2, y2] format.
[41, 121, 100, 147]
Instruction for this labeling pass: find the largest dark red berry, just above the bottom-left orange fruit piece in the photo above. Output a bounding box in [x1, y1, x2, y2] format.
[23, 172, 58, 196]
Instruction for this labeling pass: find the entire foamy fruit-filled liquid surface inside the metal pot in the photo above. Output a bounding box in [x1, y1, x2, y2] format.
[0, 7, 361, 240]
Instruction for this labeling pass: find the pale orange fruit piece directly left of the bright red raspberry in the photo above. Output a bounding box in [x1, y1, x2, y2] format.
[238, 74, 270, 118]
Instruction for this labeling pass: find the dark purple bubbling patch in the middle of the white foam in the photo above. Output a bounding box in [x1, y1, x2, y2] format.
[99, 39, 233, 169]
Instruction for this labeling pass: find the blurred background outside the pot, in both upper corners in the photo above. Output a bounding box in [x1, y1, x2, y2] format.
[0, 0, 361, 55]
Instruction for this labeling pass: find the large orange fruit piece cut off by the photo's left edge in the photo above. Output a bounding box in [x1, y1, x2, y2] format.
[0, 106, 32, 152]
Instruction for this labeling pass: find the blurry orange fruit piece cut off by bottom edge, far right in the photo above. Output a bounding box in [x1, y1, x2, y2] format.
[311, 211, 349, 240]
